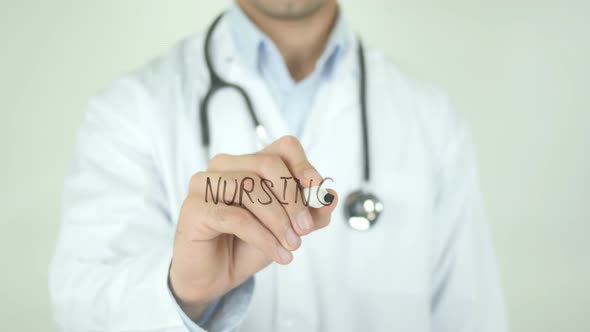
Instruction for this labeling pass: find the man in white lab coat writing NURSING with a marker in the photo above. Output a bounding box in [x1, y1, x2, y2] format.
[50, 0, 507, 332]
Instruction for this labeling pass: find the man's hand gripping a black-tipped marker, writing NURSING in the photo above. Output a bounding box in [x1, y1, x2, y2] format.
[169, 136, 338, 320]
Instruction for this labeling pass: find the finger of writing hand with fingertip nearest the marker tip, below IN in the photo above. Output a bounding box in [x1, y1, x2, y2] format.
[209, 153, 313, 235]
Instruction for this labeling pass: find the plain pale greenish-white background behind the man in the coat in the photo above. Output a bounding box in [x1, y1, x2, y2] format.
[0, 0, 590, 332]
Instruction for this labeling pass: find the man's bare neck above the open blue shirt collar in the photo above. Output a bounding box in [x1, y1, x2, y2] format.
[237, 0, 338, 81]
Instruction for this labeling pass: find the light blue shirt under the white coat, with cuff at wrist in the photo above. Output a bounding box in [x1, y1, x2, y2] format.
[178, 3, 348, 331]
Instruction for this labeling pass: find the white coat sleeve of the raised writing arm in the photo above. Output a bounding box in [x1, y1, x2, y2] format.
[49, 78, 253, 331]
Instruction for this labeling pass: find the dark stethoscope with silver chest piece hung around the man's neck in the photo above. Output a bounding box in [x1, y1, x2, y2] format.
[199, 13, 383, 231]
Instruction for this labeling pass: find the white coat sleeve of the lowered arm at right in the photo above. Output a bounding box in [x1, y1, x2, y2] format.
[431, 98, 508, 332]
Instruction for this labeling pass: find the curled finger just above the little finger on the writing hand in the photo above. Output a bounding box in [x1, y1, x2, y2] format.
[195, 172, 302, 250]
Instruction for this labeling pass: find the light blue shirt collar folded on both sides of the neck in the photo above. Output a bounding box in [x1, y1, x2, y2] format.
[227, 3, 349, 80]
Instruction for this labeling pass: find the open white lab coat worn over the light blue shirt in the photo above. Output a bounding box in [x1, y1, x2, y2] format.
[50, 14, 506, 332]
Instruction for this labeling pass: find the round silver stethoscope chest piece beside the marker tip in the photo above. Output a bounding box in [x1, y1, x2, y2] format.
[344, 190, 383, 231]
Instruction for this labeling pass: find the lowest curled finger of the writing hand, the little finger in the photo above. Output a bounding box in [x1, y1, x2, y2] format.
[205, 200, 293, 267]
